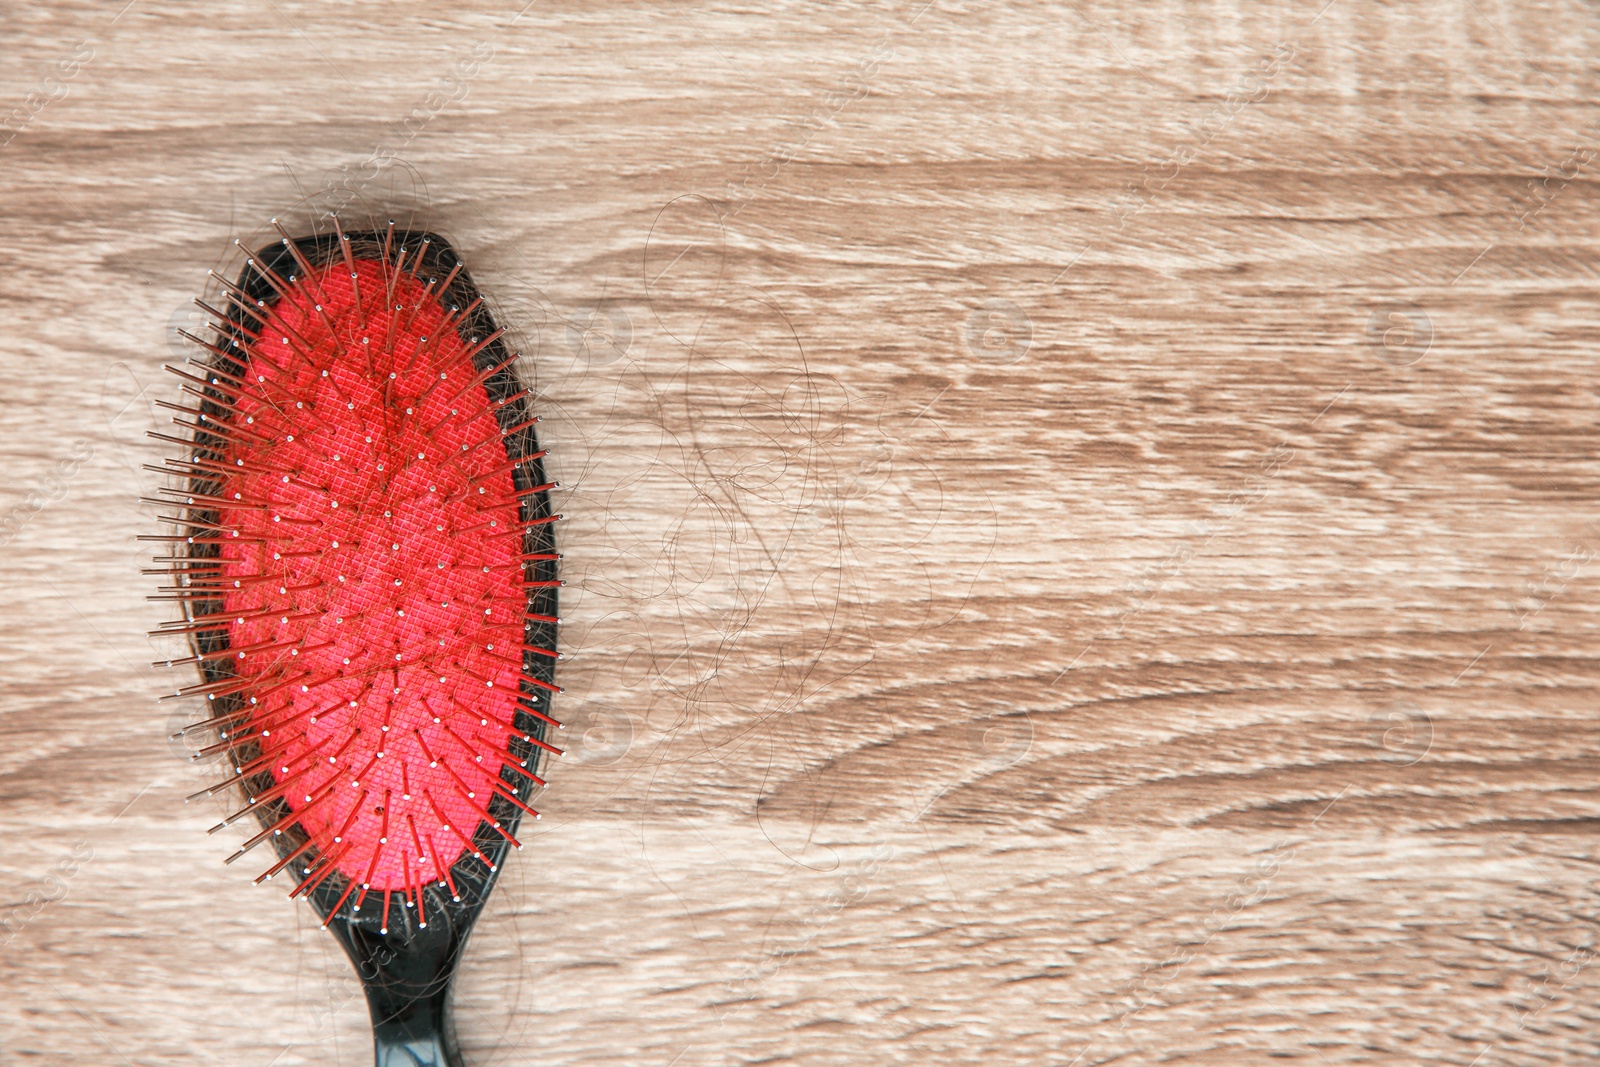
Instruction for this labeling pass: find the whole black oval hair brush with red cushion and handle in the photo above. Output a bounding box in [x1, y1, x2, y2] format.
[146, 219, 560, 1067]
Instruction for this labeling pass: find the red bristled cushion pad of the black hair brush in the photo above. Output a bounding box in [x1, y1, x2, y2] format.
[158, 225, 558, 913]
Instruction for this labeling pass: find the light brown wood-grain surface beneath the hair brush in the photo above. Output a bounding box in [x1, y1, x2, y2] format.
[0, 0, 1600, 1067]
